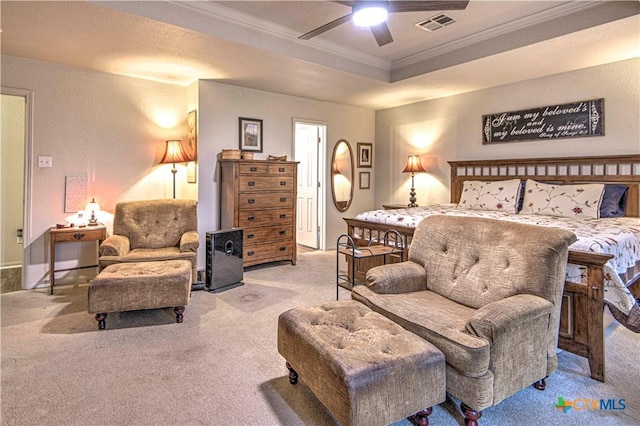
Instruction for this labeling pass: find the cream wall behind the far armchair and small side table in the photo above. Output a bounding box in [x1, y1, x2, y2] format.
[1, 56, 192, 288]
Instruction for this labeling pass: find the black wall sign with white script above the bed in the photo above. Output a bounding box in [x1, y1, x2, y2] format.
[482, 99, 604, 145]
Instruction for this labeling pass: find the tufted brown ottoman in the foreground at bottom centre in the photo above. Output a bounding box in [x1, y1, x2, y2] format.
[278, 300, 446, 426]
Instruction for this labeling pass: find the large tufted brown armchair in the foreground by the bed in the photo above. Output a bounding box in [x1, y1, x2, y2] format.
[352, 216, 576, 424]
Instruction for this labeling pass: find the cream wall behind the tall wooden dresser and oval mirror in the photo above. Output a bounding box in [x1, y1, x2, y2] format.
[198, 81, 375, 260]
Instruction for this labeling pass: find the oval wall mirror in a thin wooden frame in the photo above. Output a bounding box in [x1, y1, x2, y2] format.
[331, 139, 354, 212]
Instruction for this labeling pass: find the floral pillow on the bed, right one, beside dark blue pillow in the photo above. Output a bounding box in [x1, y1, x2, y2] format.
[521, 179, 604, 218]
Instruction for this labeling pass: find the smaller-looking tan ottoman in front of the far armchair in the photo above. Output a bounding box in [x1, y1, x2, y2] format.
[87, 260, 191, 330]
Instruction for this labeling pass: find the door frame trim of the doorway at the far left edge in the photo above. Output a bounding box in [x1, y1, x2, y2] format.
[0, 86, 34, 289]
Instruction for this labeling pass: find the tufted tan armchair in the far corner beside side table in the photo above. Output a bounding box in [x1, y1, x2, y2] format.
[98, 200, 200, 282]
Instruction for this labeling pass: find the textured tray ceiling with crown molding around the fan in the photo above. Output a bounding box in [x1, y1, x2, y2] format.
[0, 0, 640, 109]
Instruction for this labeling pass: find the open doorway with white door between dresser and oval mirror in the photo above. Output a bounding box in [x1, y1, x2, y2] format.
[293, 119, 327, 250]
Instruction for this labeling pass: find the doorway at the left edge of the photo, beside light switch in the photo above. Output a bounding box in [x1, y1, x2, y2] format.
[0, 87, 33, 293]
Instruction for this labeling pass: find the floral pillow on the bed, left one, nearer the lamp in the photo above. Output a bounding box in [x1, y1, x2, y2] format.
[458, 179, 520, 213]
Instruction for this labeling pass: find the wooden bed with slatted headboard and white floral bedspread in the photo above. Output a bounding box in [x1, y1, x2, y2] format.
[344, 154, 640, 382]
